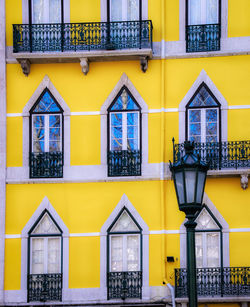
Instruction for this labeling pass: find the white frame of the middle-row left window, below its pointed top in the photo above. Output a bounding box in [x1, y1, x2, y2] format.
[31, 112, 63, 152]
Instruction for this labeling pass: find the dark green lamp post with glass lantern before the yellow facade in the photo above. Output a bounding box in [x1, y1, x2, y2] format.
[170, 141, 209, 307]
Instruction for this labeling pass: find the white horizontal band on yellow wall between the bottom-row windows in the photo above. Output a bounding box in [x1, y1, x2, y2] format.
[5, 228, 250, 239]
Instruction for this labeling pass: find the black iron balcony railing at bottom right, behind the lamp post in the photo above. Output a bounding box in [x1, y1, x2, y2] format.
[175, 267, 250, 297]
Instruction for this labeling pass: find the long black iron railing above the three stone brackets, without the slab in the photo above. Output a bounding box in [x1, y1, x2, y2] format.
[13, 20, 153, 53]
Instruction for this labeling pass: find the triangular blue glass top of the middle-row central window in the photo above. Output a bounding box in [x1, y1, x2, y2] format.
[110, 88, 140, 111]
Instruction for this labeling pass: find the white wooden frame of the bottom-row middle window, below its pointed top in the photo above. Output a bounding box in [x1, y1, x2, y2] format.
[109, 232, 141, 272]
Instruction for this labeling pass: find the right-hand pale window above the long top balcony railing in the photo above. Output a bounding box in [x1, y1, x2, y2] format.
[108, 0, 141, 21]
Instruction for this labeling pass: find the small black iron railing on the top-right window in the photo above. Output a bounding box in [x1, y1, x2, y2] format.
[186, 24, 221, 52]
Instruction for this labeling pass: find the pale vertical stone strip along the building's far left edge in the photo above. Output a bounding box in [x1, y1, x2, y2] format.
[0, 1, 6, 304]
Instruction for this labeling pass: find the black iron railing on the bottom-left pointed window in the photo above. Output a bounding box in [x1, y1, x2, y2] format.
[28, 274, 62, 302]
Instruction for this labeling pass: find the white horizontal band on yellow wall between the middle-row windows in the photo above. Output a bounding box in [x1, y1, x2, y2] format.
[6, 104, 250, 117]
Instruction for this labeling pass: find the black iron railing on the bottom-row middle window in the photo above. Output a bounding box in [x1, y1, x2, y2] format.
[107, 271, 142, 300]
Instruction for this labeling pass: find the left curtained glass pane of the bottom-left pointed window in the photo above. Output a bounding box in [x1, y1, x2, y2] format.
[31, 238, 45, 274]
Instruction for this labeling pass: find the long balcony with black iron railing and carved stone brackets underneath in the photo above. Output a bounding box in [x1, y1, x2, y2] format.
[13, 20, 153, 75]
